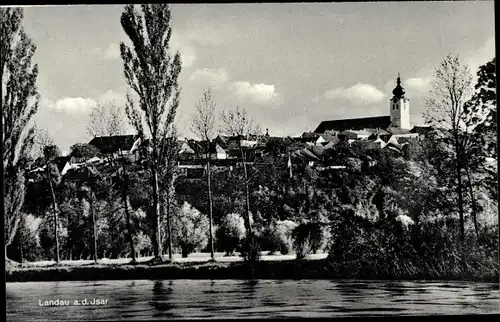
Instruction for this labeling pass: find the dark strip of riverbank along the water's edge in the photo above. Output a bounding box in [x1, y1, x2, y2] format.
[6, 254, 498, 282]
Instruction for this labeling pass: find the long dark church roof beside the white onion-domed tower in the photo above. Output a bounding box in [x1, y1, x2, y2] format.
[314, 115, 391, 133]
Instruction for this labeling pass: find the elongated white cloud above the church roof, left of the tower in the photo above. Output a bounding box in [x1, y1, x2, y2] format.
[324, 83, 385, 105]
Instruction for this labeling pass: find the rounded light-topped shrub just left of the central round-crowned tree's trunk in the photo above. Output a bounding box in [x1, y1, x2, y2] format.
[216, 213, 246, 255]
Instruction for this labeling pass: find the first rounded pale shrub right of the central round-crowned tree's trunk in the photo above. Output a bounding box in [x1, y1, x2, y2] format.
[264, 220, 298, 255]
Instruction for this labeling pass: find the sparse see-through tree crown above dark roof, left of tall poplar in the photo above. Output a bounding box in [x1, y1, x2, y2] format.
[87, 101, 125, 138]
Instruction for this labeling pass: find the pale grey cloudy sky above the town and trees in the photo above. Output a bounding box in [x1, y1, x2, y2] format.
[20, 1, 495, 152]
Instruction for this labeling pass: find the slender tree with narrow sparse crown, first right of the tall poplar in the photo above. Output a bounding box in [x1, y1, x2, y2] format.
[191, 88, 216, 260]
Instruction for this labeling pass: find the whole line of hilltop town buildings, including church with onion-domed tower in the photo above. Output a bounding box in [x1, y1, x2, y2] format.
[25, 75, 446, 184]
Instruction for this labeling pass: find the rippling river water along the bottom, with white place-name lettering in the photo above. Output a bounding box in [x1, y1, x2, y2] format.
[6, 280, 500, 321]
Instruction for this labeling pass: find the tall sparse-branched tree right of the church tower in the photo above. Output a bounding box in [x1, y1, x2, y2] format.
[424, 55, 472, 241]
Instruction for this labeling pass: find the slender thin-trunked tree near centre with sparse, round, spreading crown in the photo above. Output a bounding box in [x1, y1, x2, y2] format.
[221, 107, 260, 259]
